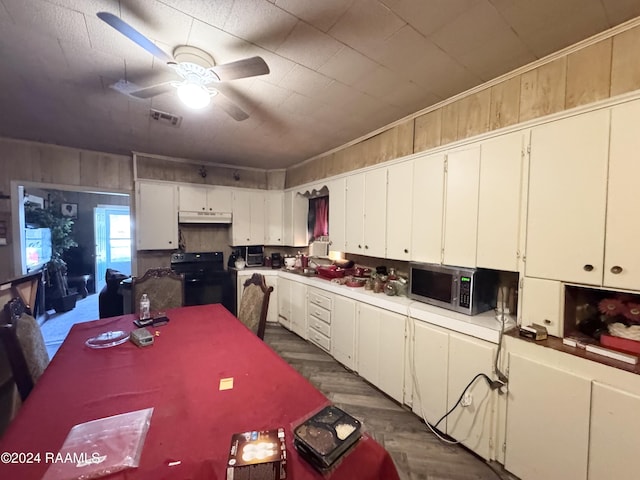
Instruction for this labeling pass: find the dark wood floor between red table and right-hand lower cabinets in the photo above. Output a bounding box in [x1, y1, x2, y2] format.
[265, 324, 517, 480]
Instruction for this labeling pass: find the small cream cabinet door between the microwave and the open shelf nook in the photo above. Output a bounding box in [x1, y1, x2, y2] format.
[518, 277, 564, 337]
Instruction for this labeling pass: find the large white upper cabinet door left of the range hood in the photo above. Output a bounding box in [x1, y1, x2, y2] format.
[136, 182, 178, 250]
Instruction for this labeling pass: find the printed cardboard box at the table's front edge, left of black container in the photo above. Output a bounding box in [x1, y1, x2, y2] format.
[227, 428, 287, 480]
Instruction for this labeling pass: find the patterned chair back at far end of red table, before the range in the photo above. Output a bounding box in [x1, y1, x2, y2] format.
[131, 268, 184, 313]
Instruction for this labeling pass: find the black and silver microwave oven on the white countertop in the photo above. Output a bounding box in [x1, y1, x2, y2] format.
[409, 262, 498, 315]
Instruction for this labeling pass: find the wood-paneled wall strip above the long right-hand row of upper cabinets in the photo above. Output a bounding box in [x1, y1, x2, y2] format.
[286, 27, 640, 188]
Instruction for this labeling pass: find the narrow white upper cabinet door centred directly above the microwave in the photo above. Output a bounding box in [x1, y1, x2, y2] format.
[443, 146, 480, 267]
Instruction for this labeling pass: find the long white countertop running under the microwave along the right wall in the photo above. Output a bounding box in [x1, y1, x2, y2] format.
[238, 267, 516, 344]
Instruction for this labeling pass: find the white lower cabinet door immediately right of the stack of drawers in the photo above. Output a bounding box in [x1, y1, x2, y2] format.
[329, 294, 356, 370]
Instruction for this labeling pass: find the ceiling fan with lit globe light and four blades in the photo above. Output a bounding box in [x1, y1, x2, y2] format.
[97, 12, 269, 121]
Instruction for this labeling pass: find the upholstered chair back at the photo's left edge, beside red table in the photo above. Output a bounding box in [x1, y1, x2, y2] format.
[0, 298, 49, 401]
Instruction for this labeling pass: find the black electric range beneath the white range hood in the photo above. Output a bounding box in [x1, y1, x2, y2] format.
[171, 252, 235, 312]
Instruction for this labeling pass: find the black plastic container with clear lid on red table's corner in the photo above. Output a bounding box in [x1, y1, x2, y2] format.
[293, 405, 362, 472]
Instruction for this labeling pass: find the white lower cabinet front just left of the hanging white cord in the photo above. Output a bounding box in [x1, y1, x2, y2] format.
[357, 303, 406, 403]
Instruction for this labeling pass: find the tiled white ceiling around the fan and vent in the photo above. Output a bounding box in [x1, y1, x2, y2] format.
[0, 0, 640, 169]
